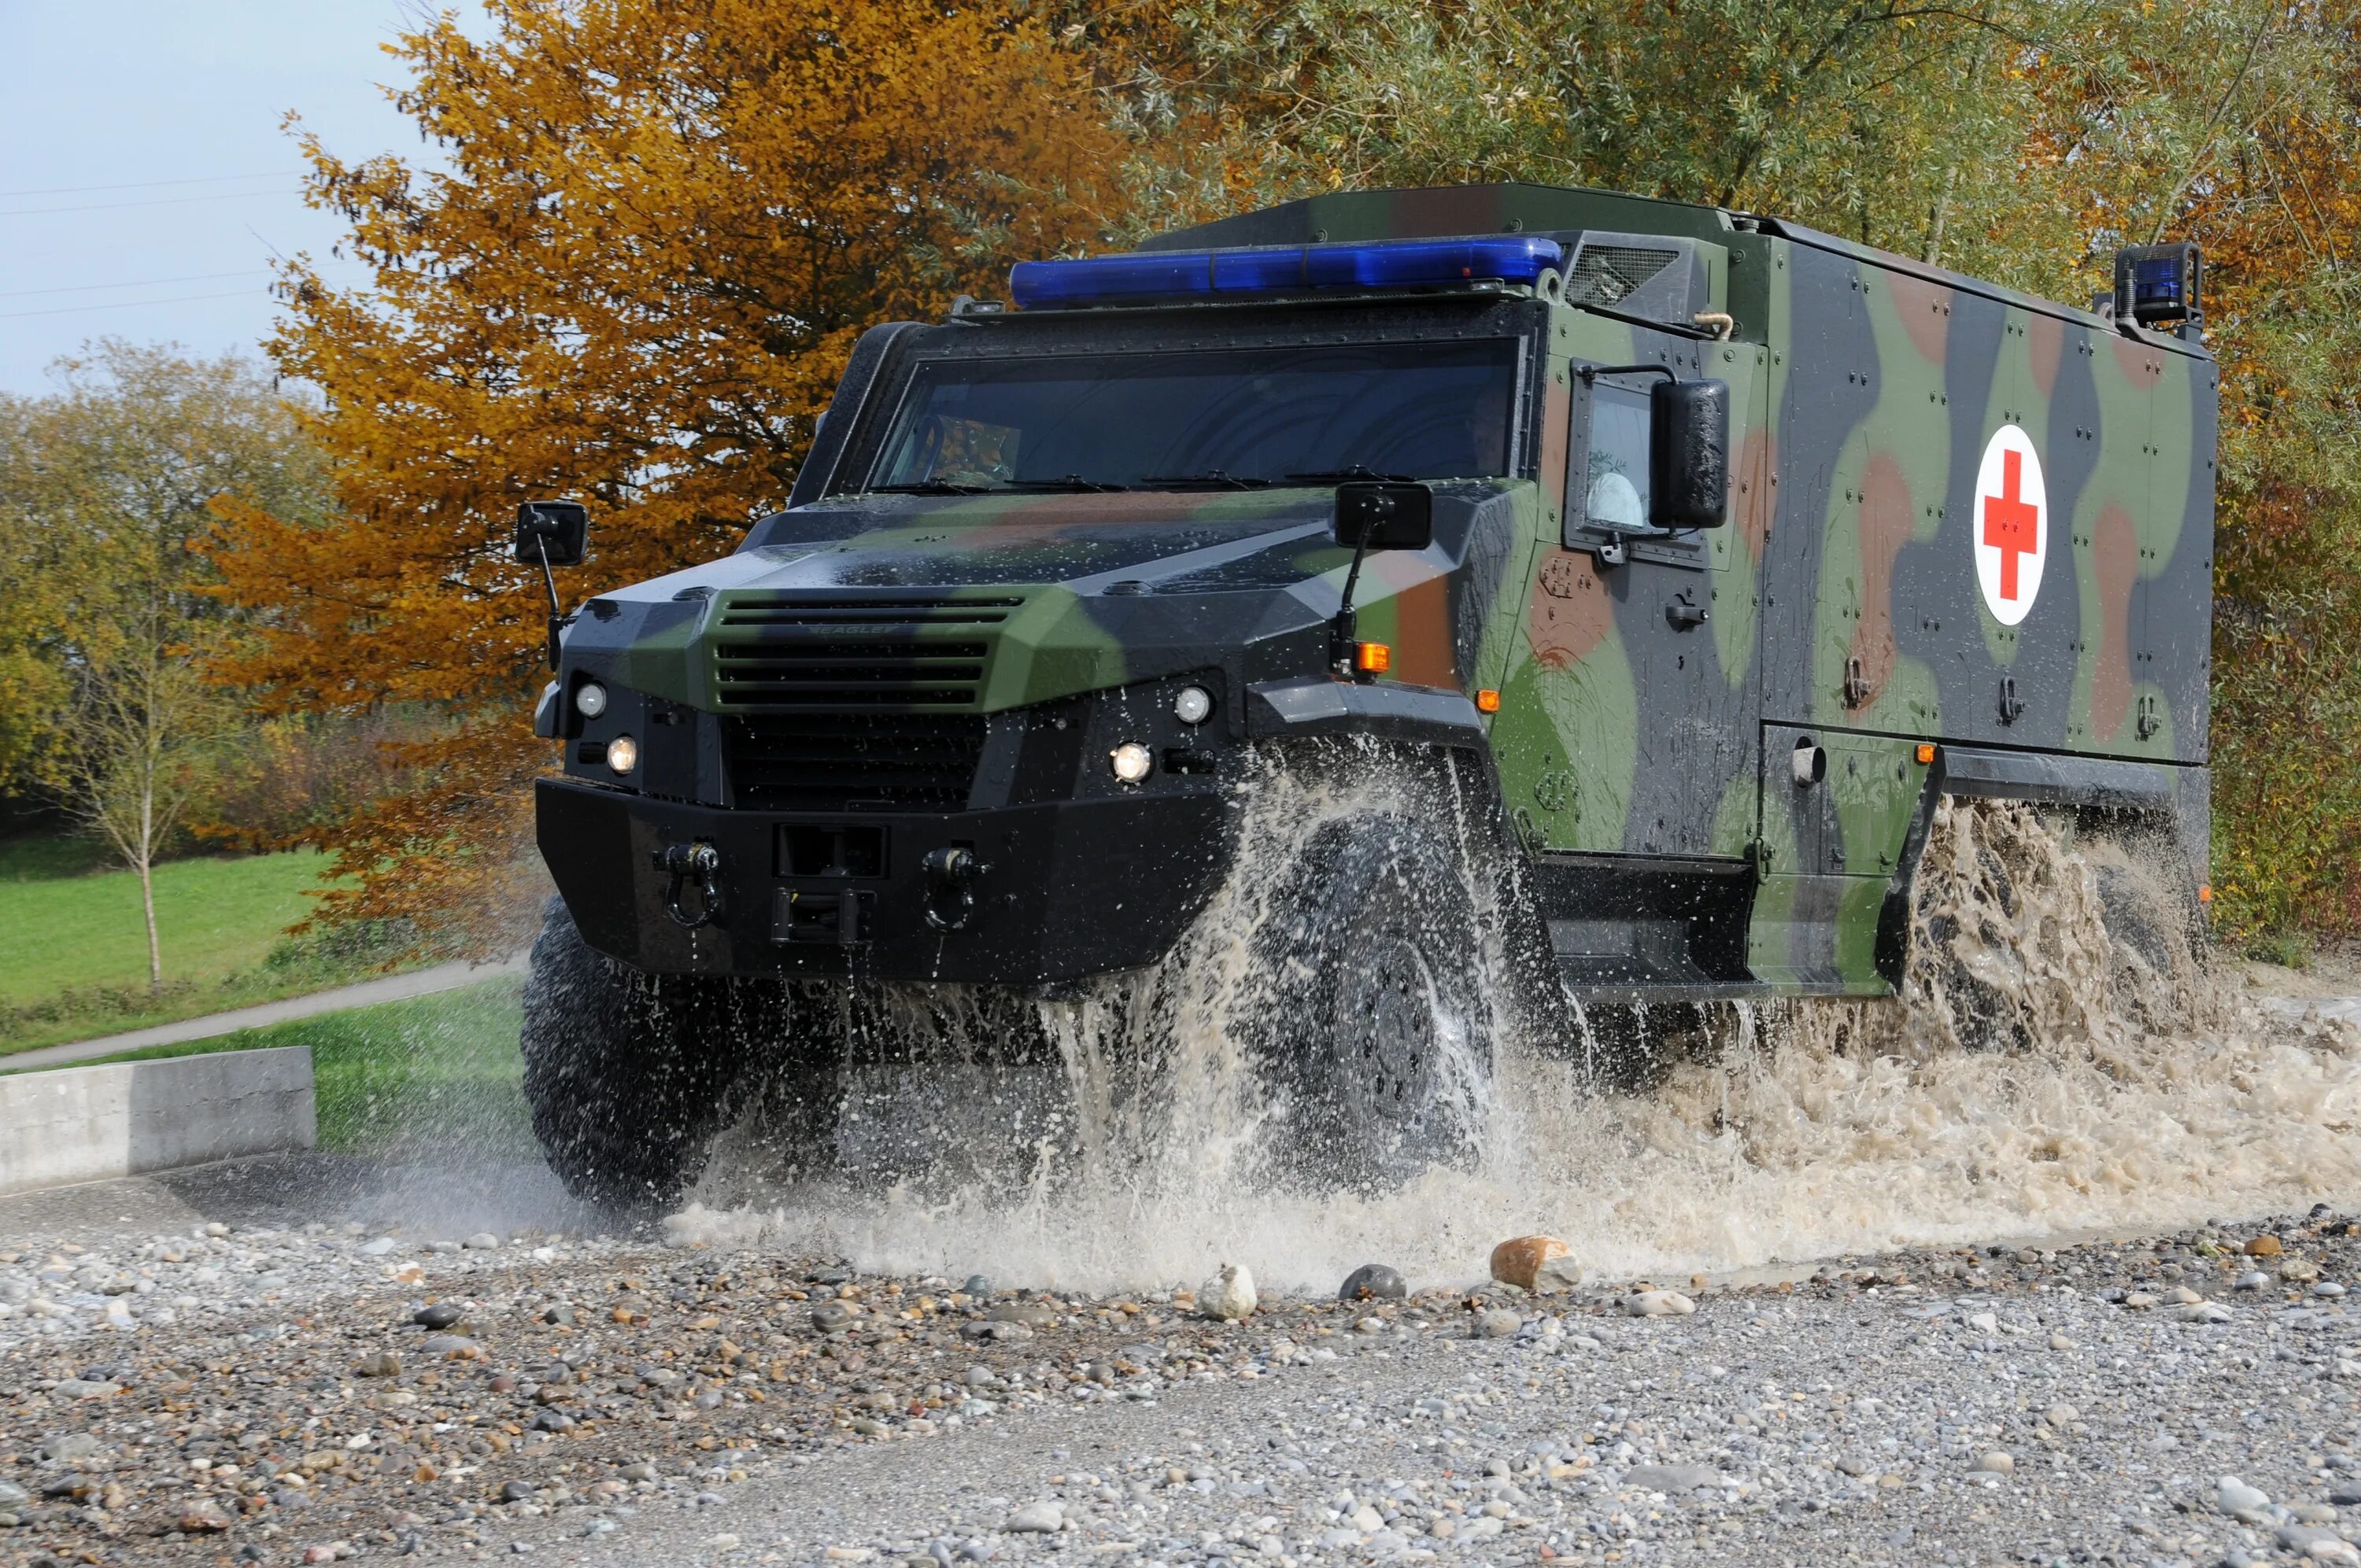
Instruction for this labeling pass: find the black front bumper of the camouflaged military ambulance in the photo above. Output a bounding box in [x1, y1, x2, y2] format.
[536, 779, 1232, 985]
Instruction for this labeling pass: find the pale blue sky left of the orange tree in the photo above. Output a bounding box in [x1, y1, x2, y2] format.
[0, 0, 479, 394]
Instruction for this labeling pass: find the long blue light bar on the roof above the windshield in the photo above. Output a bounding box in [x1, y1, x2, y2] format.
[1008, 234, 1565, 309]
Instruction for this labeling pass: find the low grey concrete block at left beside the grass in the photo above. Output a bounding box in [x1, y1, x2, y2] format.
[0, 1046, 319, 1193]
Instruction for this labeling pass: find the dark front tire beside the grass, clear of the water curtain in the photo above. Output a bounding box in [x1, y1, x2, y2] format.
[522, 900, 770, 1214]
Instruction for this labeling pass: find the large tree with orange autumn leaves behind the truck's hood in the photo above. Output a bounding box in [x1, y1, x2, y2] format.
[217, 0, 1119, 940]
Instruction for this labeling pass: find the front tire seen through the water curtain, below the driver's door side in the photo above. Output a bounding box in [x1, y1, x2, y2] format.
[1258, 817, 1495, 1190]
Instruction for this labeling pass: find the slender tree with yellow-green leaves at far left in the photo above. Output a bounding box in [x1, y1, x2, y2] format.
[0, 342, 323, 987]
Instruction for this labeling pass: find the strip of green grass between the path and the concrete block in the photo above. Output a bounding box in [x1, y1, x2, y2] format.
[36, 978, 538, 1160]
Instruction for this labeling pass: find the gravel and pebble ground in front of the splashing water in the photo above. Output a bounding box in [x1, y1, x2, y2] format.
[0, 1162, 2361, 1568]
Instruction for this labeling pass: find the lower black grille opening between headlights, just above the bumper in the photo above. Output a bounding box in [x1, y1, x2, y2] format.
[722, 713, 985, 813]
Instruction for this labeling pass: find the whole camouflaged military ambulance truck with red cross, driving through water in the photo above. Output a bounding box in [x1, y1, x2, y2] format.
[517, 184, 2217, 1202]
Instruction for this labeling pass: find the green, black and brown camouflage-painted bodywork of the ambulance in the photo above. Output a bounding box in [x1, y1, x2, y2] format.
[541, 184, 2217, 992]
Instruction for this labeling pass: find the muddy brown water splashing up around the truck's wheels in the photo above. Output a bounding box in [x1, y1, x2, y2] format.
[666, 767, 2361, 1289]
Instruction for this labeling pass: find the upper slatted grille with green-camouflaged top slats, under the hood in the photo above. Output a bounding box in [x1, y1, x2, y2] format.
[713, 592, 1025, 710]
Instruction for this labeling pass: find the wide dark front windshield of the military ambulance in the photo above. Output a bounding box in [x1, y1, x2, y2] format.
[869, 338, 1518, 489]
